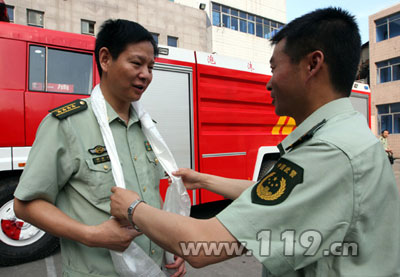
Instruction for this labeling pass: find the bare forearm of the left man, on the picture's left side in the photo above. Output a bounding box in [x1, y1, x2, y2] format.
[14, 199, 91, 246]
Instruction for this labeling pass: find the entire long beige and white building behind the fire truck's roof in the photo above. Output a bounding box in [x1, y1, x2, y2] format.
[6, 0, 286, 64]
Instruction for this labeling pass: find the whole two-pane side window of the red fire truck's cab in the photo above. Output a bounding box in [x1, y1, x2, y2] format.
[29, 45, 93, 94]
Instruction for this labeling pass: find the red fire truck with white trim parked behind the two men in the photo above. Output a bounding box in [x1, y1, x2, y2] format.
[0, 22, 370, 266]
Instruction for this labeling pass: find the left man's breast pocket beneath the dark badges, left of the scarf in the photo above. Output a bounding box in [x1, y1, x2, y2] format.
[86, 156, 115, 203]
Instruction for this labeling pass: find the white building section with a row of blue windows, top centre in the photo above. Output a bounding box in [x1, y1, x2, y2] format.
[175, 0, 286, 64]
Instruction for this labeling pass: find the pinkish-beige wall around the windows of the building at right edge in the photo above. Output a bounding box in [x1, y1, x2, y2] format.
[369, 4, 400, 157]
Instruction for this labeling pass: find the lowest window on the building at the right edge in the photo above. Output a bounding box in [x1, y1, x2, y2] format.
[376, 102, 400, 134]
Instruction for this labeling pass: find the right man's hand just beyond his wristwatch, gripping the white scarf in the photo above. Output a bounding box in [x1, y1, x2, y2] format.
[110, 187, 140, 224]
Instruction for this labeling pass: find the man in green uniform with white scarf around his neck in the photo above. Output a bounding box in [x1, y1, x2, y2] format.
[14, 20, 185, 276]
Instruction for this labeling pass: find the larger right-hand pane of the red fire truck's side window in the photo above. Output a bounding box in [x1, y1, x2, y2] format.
[46, 48, 93, 94]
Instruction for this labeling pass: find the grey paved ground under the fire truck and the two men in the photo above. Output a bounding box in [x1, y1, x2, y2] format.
[0, 159, 400, 277]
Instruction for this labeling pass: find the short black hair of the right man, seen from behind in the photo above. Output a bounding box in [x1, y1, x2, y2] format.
[271, 7, 361, 96]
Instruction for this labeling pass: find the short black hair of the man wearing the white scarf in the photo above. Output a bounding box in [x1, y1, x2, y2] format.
[95, 19, 158, 77]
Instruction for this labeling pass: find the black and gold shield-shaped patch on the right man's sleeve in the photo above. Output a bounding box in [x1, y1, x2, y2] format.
[251, 158, 304, 205]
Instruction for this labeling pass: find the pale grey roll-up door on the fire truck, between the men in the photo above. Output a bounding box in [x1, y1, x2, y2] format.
[140, 63, 194, 168]
